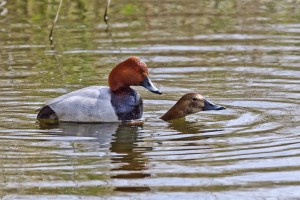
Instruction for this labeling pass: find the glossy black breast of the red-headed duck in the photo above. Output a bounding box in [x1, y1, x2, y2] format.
[111, 89, 143, 120]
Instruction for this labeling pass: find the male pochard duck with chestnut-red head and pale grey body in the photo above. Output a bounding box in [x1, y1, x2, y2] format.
[37, 57, 161, 122]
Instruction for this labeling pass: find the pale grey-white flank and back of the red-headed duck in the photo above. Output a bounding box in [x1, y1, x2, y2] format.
[47, 86, 119, 122]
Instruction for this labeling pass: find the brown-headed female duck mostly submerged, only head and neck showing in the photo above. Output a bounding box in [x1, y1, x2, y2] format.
[161, 93, 225, 121]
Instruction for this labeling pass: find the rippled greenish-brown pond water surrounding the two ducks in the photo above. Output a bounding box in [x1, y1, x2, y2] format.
[0, 0, 300, 199]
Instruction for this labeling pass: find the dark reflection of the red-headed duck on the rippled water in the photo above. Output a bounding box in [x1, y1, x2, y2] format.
[40, 123, 151, 192]
